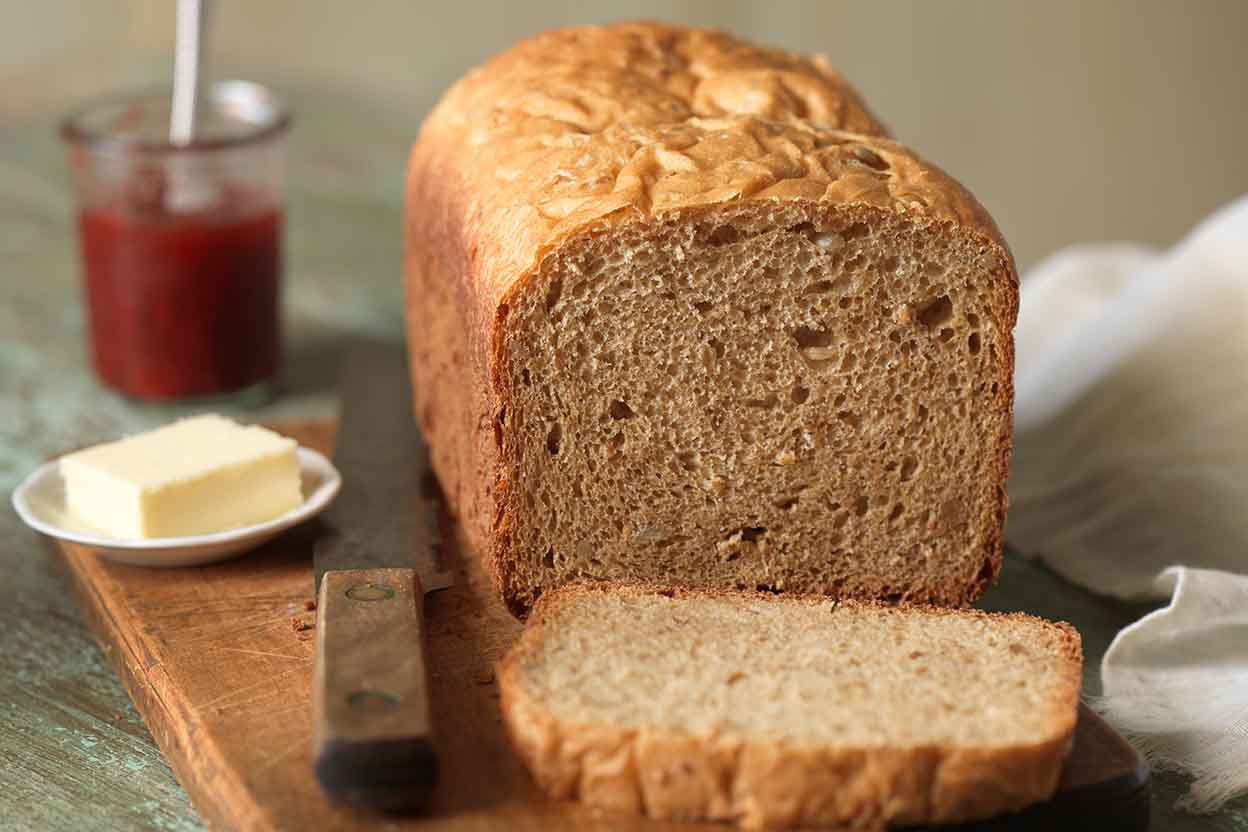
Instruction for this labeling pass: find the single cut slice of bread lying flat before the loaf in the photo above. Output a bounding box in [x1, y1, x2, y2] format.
[499, 584, 1082, 828]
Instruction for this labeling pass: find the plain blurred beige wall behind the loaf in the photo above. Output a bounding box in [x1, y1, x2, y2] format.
[0, 0, 1248, 266]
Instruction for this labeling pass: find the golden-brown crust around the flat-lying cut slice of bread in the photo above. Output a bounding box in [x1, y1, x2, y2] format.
[498, 584, 1083, 828]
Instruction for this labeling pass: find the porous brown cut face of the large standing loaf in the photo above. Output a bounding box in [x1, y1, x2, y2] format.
[502, 202, 1012, 604]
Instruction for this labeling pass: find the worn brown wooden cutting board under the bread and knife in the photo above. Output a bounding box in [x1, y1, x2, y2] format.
[60, 423, 1148, 832]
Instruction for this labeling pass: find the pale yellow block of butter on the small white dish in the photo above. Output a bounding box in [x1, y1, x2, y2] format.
[60, 415, 303, 539]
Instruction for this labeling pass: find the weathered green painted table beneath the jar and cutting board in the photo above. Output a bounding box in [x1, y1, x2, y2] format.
[0, 81, 1248, 832]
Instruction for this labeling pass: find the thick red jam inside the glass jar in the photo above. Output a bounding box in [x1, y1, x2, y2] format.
[79, 188, 282, 400]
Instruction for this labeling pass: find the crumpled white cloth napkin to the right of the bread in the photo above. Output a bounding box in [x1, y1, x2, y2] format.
[1006, 197, 1248, 811]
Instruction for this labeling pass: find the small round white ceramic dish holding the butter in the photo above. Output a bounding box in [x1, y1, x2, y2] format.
[12, 447, 342, 566]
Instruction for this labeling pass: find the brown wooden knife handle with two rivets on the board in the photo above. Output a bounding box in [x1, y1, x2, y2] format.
[312, 569, 438, 811]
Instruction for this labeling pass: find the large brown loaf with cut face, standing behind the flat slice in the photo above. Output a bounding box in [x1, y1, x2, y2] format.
[404, 24, 1017, 615]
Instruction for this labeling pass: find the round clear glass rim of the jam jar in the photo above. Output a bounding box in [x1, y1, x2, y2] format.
[60, 80, 292, 153]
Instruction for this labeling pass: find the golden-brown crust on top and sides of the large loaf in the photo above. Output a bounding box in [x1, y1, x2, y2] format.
[406, 24, 1017, 614]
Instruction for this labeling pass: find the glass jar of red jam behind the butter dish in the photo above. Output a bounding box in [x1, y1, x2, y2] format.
[61, 81, 290, 402]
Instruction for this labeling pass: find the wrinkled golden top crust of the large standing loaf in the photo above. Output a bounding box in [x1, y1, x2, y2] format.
[411, 22, 1006, 311]
